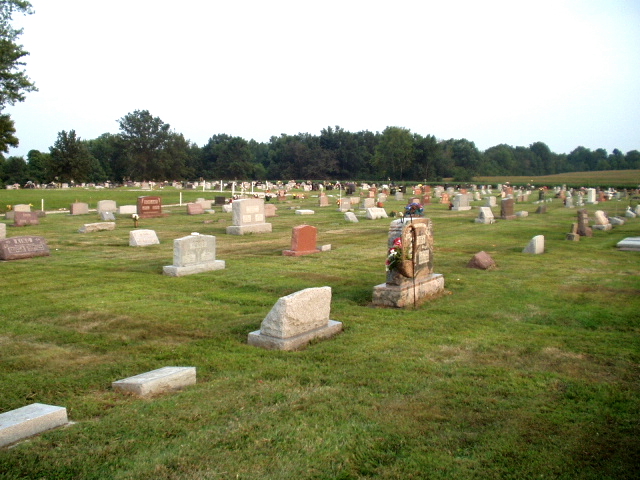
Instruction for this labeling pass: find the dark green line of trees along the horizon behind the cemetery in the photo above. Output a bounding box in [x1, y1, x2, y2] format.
[0, 110, 640, 185]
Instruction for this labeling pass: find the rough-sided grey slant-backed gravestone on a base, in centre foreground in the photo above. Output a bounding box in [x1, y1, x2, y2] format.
[247, 287, 342, 351]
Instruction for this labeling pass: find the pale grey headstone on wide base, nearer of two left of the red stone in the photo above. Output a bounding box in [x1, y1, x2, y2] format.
[162, 233, 225, 277]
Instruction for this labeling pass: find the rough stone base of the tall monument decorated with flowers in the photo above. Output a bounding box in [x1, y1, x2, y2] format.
[373, 273, 444, 308]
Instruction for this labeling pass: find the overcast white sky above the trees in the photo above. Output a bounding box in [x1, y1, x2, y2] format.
[6, 0, 640, 155]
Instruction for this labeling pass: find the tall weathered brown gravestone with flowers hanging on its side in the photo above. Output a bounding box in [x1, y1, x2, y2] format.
[373, 218, 444, 308]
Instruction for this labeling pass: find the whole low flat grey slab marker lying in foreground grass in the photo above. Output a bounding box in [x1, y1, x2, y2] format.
[111, 367, 196, 397]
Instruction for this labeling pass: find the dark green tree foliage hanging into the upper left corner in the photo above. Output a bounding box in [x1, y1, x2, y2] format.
[0, 0, 37, 157]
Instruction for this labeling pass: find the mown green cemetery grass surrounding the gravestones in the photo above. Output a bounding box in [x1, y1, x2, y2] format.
[0, 190, 640, 480]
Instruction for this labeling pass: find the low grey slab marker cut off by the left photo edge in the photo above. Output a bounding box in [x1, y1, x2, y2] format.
[0, 403, 69, 447]
